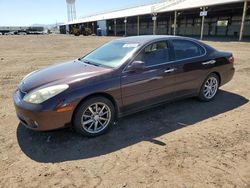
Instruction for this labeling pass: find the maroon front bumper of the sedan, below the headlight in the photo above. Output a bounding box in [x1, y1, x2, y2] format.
[13, 90, 73, 131]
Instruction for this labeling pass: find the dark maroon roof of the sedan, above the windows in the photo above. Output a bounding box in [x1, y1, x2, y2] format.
[116, 35, 196, 44]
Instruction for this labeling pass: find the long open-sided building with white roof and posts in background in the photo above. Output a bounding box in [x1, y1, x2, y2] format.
[60, 0, 250, 39]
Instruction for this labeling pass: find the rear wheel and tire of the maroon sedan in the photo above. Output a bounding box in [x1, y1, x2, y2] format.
[198, 73, 220, 102]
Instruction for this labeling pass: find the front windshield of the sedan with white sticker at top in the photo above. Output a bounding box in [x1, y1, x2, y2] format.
[80, 41, 139, 68]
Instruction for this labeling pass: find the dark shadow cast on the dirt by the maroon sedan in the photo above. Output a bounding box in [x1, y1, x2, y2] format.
[17, 91, 249, 163]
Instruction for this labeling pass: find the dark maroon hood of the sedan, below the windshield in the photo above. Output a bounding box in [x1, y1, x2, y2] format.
[18, 61, 112, 93]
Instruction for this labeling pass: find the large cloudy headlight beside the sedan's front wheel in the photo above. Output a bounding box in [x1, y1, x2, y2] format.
[23, 84, 69, 104]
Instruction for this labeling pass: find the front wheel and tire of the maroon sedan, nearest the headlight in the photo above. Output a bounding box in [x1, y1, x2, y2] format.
[73, 97, 115, 137]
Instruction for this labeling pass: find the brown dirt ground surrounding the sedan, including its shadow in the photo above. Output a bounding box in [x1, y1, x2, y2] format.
[0, 35, 250, 188]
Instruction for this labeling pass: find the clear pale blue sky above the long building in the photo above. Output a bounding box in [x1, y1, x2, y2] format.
[0, 0, 160, 26]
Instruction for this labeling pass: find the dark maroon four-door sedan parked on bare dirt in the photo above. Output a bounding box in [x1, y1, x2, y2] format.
[13, 36, 235, 137]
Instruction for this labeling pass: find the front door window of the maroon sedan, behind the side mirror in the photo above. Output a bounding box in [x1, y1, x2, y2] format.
[135, 41, 170, 67]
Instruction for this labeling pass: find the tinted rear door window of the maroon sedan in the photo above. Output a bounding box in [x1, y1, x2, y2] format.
[172, 39, 205, 60]
